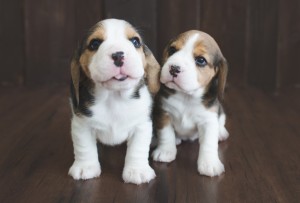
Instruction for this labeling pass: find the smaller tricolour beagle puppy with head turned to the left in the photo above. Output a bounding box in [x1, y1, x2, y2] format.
[152, 30, 228, 176]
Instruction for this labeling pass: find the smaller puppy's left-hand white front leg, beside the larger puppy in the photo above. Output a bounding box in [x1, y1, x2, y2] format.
[152, 123, 177, 162]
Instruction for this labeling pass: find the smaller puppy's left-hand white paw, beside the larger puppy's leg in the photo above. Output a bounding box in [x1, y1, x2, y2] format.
[152, 147, 177, 162]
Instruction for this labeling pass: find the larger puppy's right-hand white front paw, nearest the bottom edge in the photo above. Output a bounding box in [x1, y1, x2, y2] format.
[122, 166, 155, 185]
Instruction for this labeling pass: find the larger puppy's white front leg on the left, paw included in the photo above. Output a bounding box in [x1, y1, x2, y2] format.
[69, 119, 101, 180]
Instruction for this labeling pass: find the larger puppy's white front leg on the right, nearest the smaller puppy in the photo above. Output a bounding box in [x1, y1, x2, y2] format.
[122, 122, 155, 184]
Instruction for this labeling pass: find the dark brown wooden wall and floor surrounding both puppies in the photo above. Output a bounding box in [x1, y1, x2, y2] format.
[0, 0, 300, 203]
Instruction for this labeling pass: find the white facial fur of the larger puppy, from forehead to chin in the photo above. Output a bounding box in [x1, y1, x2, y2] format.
[89, 19, 144, 90]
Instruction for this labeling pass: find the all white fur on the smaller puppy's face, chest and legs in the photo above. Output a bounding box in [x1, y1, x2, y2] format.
[152, 34, 228, 176]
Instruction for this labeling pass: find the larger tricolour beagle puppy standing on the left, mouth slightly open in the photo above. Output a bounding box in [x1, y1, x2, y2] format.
[69, 19, 160, 184]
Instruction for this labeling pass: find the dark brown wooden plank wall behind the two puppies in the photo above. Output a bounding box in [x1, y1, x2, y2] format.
[0, 0, 300, 91]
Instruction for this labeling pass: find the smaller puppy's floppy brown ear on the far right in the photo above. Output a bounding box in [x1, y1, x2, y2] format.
[218, 57, 228, 100]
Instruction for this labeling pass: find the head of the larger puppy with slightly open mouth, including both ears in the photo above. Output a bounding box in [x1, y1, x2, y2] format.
[71, 19, 160, 103]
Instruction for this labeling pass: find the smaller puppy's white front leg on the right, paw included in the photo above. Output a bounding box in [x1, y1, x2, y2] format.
[197, 113, 225, 177]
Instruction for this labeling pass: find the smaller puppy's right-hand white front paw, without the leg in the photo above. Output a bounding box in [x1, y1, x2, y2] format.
[198, 156, 225, 177]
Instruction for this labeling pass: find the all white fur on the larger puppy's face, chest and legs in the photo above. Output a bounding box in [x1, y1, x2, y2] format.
[69, 20, 155, 184]
